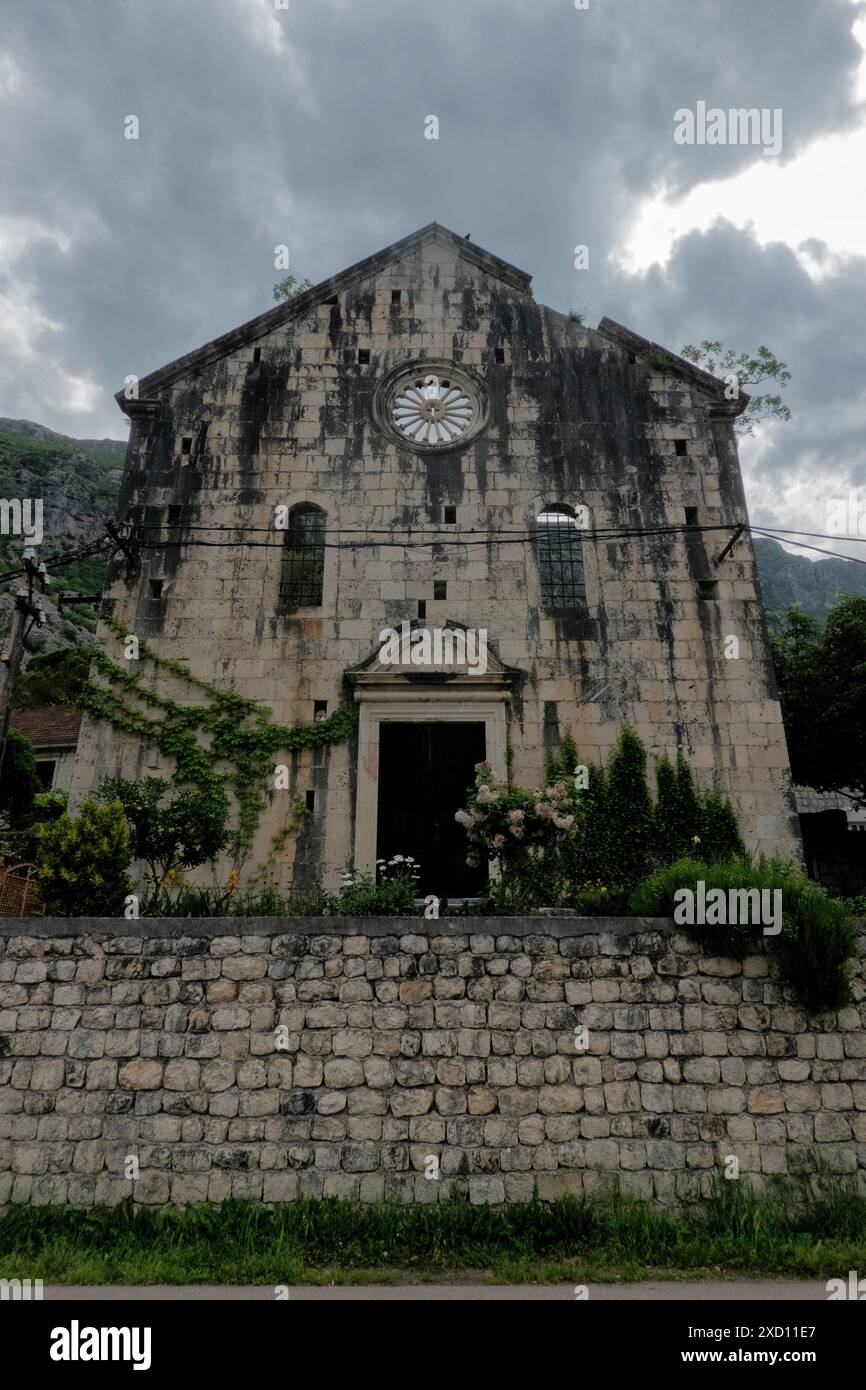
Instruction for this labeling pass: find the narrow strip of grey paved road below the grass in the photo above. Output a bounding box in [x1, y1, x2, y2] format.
[44, 1279, 827, 1302]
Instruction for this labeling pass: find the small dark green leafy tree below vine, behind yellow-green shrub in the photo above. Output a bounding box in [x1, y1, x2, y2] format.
[99, 777, 228, 887]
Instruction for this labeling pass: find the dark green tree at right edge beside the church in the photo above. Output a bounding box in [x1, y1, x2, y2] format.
[770, 594, 866, 805]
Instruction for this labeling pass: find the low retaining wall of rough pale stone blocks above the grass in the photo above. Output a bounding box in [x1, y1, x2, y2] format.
[0, 919, 866, 1205]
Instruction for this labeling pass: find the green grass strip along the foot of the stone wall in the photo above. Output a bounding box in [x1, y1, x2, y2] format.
[0, 1179, 866, 1284]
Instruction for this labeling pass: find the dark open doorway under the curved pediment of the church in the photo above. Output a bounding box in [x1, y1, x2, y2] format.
[377, 723, 487, 898]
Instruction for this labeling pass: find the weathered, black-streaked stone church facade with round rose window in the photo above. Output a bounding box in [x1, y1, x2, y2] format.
[74, 216, 799, 894]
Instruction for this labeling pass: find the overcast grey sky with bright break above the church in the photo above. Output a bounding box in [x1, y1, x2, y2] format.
[0, 0, 866, 553]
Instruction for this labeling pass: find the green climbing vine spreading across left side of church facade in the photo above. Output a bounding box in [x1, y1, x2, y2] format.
[76, 616, 356, 851]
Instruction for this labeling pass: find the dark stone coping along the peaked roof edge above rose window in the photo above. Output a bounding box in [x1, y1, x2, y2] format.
[114, 222, 532, 414]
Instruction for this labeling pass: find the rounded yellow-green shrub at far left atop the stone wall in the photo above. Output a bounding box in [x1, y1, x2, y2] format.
[36, 796, 132, 917]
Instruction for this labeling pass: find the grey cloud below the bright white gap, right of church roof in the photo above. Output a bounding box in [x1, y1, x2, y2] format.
[610, 222, 866, 542]
